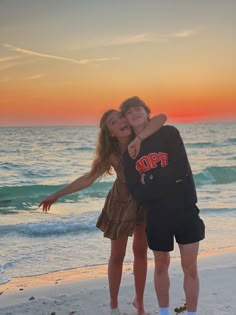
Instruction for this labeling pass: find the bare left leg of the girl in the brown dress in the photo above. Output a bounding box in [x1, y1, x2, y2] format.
[108, 236, 128, 310]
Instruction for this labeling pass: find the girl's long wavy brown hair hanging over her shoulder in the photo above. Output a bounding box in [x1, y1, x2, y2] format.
[90, 109, 120, 175]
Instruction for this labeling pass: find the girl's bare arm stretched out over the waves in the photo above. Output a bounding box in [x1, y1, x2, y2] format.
[39, 172, 103, 212]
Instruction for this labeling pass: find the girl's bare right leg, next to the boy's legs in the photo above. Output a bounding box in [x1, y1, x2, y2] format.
[133, 224, 148, 315]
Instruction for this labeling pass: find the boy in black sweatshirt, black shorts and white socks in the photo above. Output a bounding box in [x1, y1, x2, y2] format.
[120, 96, 205, 315]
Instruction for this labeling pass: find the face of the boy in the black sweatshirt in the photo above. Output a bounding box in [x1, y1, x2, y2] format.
[125, 106, 148, 128]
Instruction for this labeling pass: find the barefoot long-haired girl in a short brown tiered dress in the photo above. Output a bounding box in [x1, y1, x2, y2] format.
[39, 109, 166, 315]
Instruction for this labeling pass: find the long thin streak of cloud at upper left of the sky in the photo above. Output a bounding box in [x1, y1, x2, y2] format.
[4, 44, 120, 65]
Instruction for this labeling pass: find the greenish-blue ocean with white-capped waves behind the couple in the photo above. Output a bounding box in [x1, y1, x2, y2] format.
[0, 122, 236, 284]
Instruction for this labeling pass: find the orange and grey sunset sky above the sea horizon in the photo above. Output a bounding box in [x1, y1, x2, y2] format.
[0, 0, 236, 126]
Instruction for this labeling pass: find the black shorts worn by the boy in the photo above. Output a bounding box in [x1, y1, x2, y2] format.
[146, 205, 205, 252]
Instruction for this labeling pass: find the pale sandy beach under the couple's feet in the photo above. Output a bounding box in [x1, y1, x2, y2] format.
[0, 248, 236, 315]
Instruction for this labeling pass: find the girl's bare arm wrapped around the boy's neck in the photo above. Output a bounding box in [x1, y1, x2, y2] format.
[128, 114, 167, 159]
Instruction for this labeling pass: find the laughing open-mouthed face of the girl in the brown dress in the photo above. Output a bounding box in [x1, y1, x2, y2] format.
[106, 111, 132, 138]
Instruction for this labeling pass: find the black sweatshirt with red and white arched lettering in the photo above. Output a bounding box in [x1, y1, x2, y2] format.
[123, 126, 197, 209]
